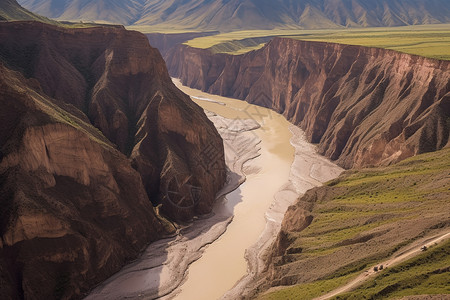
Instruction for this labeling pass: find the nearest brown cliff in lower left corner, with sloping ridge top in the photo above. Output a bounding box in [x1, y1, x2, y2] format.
[0, 64, 163, 299]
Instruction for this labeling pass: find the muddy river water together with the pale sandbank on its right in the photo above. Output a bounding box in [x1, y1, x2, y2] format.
[171, 80, 342, 299]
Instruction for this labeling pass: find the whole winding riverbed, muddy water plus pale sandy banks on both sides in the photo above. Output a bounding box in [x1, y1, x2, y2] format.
[86, 79, 342, 300]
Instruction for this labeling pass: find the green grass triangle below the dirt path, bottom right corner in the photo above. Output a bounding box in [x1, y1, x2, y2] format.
[333, 241, 450, 300]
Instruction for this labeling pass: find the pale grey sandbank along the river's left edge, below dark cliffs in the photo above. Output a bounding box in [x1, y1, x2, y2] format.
[86, 87, 261, 300]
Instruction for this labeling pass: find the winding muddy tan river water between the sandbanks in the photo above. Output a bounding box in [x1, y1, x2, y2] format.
[174, 80, 294, 300]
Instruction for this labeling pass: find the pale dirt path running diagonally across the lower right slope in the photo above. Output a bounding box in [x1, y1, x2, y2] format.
[313, 232, 450, 300]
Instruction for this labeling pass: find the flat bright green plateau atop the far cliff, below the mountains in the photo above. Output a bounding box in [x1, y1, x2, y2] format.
[186, 24, 450, 60]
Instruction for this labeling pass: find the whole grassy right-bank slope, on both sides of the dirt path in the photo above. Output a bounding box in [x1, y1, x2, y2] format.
[260, 148, 450, 299]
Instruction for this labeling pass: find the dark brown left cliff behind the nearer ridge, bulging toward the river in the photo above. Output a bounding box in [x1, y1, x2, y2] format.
[0, 22, 225, 220]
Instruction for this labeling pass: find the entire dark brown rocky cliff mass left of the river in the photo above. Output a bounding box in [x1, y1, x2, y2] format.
[0, 22, 225, 299]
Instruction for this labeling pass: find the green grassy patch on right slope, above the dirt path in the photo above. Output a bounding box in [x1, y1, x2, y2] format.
[295, 149, 450, 251]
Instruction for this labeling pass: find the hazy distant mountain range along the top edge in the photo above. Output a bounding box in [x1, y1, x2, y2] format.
[20, 0, 450, 31]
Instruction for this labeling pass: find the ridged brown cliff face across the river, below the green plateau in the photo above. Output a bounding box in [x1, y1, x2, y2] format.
[167, 38, 450, 168]
